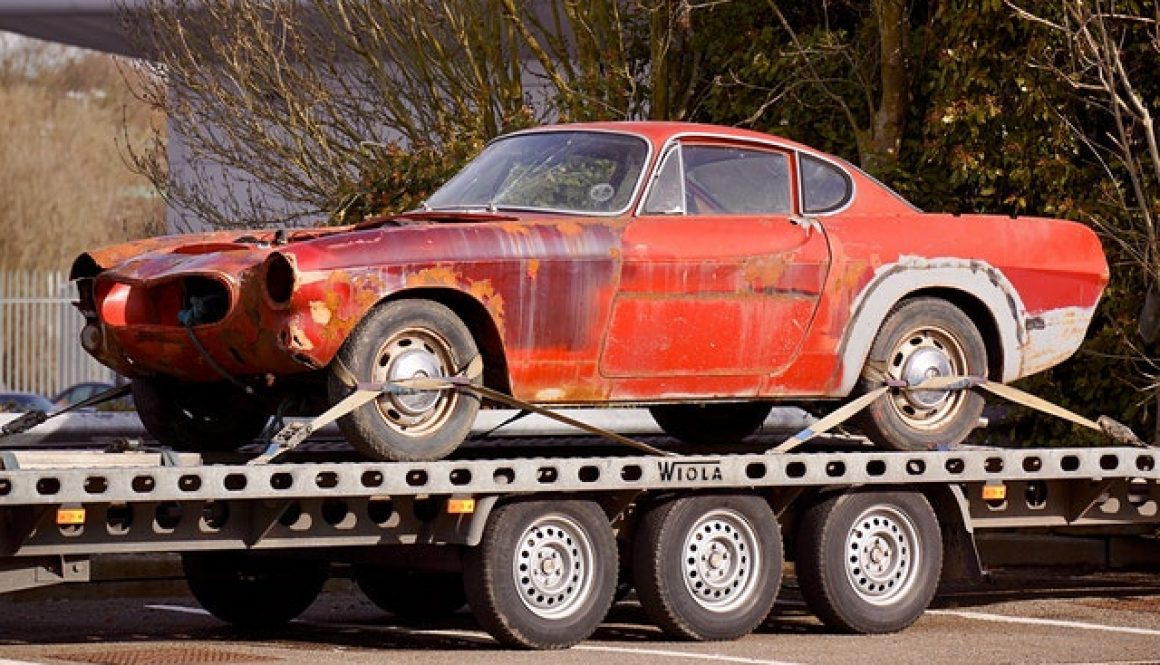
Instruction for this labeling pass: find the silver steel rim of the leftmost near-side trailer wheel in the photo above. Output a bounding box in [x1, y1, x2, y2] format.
[512, 516, 594, 619]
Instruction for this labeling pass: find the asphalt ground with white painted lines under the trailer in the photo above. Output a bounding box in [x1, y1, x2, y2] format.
[0, 570, 1160, 665]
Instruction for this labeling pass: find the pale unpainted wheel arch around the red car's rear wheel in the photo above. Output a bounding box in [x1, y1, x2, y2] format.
[834, 259, 1027, 396]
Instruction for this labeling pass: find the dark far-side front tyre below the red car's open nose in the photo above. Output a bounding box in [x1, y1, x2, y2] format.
[132, 378, 270, 451]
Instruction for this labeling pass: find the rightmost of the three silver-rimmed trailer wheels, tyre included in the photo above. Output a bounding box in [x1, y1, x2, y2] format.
[795, 492, 942, 634]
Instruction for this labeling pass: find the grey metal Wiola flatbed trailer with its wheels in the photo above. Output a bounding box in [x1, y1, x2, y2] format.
[0, 436, 1160, 649]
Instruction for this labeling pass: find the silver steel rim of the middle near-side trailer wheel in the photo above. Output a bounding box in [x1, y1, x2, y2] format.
[682, 511, 761, 612]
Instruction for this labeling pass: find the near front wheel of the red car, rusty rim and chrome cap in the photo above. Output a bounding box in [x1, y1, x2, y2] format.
[328, 299, 479, 462]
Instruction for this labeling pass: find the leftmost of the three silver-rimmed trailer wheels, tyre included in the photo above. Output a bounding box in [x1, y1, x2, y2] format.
[463, 500, 618, 649]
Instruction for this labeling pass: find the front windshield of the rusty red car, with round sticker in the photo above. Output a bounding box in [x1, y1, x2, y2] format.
[427, 131, 648, 215]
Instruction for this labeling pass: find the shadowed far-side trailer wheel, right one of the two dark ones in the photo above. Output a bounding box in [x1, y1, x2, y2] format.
[355, 565, 467, 621]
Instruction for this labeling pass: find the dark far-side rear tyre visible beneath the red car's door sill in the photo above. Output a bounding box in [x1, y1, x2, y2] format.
[648, 402, 773, 444]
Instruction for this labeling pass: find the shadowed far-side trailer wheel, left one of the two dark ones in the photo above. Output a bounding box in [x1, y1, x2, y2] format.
[181, 551, 328, 628]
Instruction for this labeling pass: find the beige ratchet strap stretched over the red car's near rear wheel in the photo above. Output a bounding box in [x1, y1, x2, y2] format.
[767, 376, 1147, 454]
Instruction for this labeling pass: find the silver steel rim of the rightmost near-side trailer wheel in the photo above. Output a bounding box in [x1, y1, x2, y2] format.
[846, 506, 920, 605]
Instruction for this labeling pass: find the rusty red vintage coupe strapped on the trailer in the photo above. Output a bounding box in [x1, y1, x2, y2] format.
[72, 122, 1108, 460]
